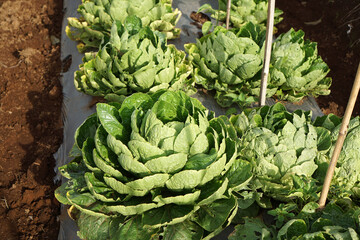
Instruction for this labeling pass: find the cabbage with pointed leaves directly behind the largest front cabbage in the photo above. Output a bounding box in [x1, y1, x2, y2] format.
[74, 16, 195, 101]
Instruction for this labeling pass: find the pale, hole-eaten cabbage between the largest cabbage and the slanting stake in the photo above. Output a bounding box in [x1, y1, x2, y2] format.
[230, 103, 331, 203]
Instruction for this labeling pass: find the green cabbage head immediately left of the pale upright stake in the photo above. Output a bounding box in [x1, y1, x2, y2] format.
[185, 23, 271, 107]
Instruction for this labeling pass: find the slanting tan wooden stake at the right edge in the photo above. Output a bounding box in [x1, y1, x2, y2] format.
[319, 64, 360, 209]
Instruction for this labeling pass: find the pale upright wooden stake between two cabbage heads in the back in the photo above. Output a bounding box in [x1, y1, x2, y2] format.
[260, 0, 275, 106]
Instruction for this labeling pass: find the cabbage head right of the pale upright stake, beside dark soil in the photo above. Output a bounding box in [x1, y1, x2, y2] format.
[270, 29, 331, 102]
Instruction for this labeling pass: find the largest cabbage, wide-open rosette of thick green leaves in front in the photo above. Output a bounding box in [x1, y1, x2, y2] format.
[56, 91, 252, 240]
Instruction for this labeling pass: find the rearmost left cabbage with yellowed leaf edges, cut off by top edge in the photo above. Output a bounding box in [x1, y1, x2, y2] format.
[66, 0, 181, 52]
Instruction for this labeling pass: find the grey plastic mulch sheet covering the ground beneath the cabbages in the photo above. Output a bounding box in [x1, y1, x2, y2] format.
[55, 0, 322, 240]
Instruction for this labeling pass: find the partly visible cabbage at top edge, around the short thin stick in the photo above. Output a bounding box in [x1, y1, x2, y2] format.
[198, 0, 283, 28]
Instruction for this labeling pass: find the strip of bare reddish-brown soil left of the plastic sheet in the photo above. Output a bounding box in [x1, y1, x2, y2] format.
[0, 0, 63, 240]
